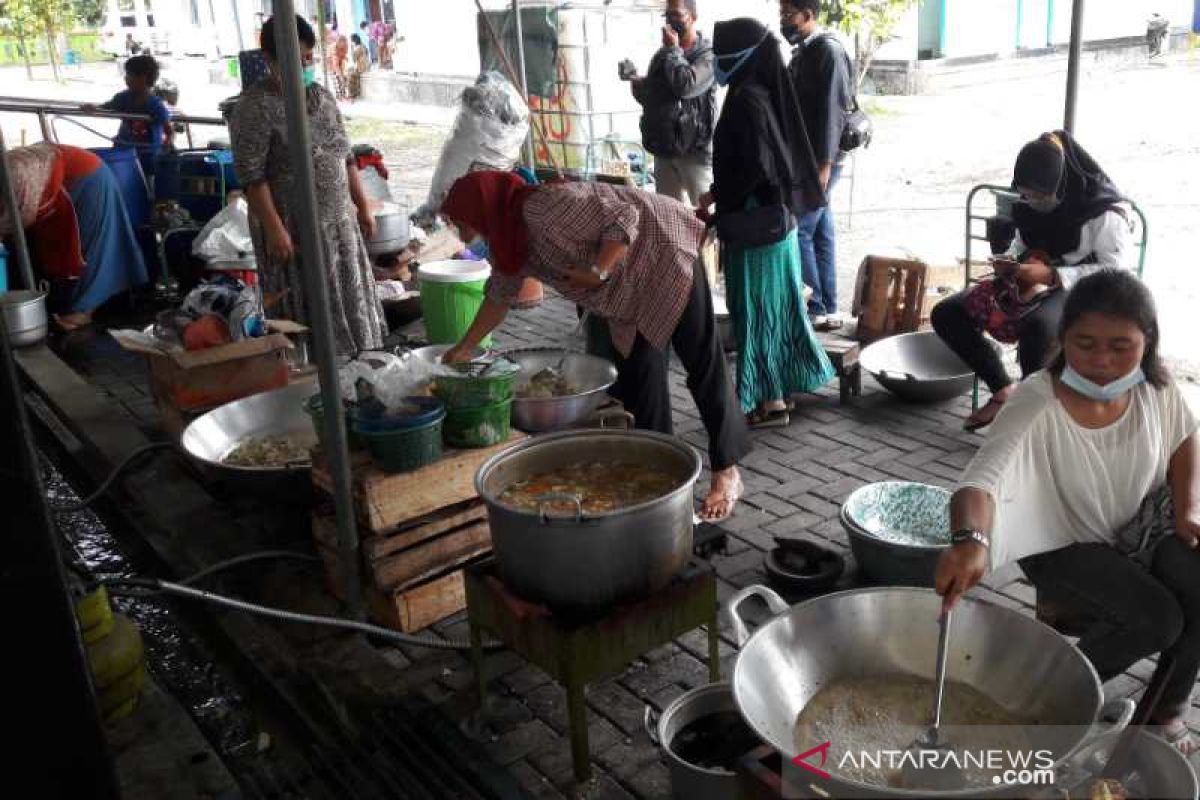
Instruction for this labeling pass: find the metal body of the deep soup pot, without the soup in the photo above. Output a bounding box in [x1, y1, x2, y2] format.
[475, 431, 701, 614]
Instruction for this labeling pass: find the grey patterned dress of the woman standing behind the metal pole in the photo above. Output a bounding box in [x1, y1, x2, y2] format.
[229, 78, 386, 355]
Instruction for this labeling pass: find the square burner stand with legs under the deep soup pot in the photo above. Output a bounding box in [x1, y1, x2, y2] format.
[464, 559, 721, 783]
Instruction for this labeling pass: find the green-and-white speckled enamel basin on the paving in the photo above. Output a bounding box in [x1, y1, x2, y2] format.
[839, 481, 950, 587]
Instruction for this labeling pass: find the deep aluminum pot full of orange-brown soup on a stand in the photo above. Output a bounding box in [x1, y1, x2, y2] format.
[475, 429, 701, 615]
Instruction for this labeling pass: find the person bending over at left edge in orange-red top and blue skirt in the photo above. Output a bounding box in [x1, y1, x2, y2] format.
[0, 143, 149, 331]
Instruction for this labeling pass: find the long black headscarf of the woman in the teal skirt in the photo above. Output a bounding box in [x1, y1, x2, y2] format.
[713, 17, 826, 213]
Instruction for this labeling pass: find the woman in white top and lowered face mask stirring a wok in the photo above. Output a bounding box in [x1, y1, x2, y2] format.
[936, 270, 1200, 753]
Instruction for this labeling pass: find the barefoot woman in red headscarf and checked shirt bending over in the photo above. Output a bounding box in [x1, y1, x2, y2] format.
[442, 172, 750, 522]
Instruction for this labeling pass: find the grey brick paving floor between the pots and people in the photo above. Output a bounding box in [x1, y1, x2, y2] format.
[59, 297, 1200, 799]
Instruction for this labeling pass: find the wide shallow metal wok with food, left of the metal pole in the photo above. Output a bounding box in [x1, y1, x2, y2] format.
[180, 381, 317, 488]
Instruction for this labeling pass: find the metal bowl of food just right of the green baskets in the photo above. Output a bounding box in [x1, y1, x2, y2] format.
[502, 348, 617, 433]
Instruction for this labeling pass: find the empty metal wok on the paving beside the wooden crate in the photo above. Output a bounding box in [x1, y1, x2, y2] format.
[858, 331, 974, 403]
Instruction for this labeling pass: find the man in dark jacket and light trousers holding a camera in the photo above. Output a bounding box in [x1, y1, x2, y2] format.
[623, 0, 716, 205]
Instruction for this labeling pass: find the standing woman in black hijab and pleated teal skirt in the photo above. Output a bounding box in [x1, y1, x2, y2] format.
[701, 18, 834, 427]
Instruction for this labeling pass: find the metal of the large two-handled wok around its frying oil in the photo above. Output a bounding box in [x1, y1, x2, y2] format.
[726, 587, 1134, 798]
